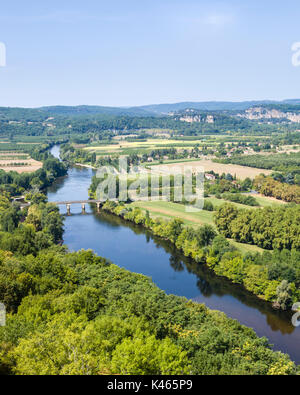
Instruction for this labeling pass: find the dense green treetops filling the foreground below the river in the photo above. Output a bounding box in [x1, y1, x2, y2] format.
[0, 249, 296, 375]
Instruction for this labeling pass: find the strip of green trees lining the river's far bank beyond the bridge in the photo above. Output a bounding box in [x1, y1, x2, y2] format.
[102, 201, 300, 309]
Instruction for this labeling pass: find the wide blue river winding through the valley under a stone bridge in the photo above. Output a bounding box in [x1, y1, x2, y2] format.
[48, 146, 300, 364]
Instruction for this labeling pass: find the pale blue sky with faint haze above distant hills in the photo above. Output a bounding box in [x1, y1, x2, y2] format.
[0, 0, 300, 107]
